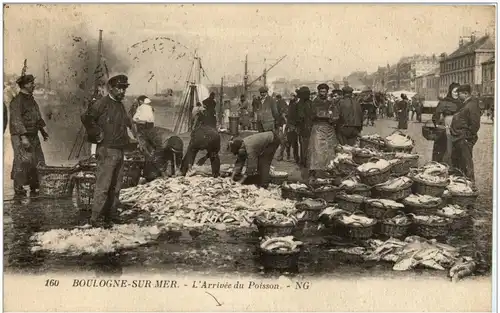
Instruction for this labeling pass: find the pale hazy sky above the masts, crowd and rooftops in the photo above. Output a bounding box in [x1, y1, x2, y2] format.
[4, 4, 495, 93]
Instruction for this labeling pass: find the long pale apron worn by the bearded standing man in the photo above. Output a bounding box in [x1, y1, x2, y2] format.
[307, 122, 338, 171]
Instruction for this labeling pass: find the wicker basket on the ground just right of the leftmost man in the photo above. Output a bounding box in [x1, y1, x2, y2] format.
[37, 166, 76, 199]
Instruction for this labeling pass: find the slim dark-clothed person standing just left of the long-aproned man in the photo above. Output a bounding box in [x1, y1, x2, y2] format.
[296, 87, 312, 168]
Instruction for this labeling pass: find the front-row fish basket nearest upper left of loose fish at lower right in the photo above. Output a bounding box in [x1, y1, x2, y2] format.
[334, 212, 377, 240]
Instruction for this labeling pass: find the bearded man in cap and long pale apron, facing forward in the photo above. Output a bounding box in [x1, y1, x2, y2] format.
[307, 84, 339, 179]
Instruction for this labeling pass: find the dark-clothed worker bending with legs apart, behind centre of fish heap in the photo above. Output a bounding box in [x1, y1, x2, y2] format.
[181, 125, 220, 177]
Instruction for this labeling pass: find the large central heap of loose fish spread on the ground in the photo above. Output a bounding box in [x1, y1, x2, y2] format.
[120, 176, 296, 230]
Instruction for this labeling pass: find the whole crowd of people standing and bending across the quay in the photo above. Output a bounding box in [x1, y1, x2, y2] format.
[0, 74, 482, 227]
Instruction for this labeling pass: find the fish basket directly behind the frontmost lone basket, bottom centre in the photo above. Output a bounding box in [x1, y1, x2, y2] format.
[253, 212, 303, 237]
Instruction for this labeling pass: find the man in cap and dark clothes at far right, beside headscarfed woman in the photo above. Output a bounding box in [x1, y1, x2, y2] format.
[450, 85, 481, 181]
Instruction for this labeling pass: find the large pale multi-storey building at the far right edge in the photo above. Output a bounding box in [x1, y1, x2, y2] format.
[439, 35, 495, 97]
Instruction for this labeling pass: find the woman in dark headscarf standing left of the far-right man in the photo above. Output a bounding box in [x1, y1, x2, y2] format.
[432, 83, 461, 166]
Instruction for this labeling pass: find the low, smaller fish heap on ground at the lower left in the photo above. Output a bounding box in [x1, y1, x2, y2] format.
[31, 225, 161, 256]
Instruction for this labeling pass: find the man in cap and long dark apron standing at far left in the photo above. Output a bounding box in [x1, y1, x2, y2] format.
[9, 74, 49, 196]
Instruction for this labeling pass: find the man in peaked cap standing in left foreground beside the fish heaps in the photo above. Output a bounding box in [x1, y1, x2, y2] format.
[82, 75, 137, 227]
